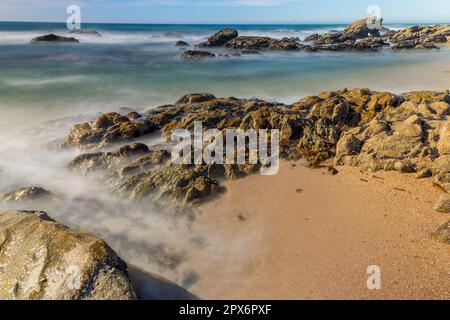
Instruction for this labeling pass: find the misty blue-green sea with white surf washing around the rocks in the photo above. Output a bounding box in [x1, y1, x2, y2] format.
[0, 23, 450, 291]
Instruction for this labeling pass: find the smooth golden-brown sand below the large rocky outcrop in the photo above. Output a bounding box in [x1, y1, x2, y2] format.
[190, 162, 450, 299]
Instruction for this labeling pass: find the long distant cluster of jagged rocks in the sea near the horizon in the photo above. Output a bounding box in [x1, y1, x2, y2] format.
[183, 19, 450, 59]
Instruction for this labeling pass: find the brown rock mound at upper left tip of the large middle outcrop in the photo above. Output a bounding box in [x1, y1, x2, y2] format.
[60, 112, 156, 150]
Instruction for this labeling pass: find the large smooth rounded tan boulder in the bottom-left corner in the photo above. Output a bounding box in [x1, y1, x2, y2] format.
[0, 211, 136, 300]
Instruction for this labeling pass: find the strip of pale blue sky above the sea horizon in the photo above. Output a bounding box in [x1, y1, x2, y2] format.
[0, 0, 450, 23]
